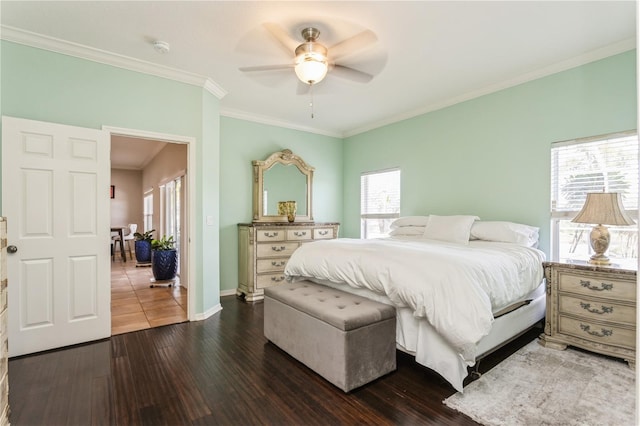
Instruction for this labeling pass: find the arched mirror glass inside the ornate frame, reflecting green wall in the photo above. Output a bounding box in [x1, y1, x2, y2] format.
[262, 163, 307, 216]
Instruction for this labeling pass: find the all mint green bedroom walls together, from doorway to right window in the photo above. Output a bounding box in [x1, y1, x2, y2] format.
[0, 41, 637, 302]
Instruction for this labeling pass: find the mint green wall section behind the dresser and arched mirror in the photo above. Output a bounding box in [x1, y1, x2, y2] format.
[220, 117, 343, 291]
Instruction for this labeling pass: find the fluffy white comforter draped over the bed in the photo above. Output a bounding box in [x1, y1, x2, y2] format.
[285, 238, 544, 363]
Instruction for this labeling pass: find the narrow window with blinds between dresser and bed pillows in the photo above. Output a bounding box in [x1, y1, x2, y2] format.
[360, 169, 400, 238]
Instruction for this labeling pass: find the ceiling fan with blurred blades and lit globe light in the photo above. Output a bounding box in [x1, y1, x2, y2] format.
[239, 23, 377, 86]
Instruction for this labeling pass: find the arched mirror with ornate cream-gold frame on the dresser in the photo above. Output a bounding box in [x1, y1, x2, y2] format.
[253, 149, 314, 222]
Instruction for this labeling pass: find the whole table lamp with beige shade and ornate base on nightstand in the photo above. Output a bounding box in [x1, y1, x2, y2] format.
[571, 192, 635, 265]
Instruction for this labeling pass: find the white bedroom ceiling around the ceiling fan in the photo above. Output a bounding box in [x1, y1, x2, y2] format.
[1, 1, 636, 142]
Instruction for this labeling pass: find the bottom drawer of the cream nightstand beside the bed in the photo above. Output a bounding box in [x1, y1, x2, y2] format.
[558, 316, 636, 349]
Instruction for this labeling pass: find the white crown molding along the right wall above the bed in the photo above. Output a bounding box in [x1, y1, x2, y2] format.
[344, 38, 636, 138]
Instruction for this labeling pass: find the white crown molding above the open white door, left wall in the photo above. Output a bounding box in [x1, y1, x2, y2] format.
[0, 25, 227, 99]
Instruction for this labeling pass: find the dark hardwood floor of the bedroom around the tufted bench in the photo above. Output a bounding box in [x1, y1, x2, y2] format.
[9, 296, 539, 426]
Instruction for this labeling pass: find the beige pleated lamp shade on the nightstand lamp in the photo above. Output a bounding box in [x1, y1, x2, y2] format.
[571, 192, 635, 226]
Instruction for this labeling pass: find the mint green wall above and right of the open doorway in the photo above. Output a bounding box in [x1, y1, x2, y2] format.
[1, 41, 220, 313]
